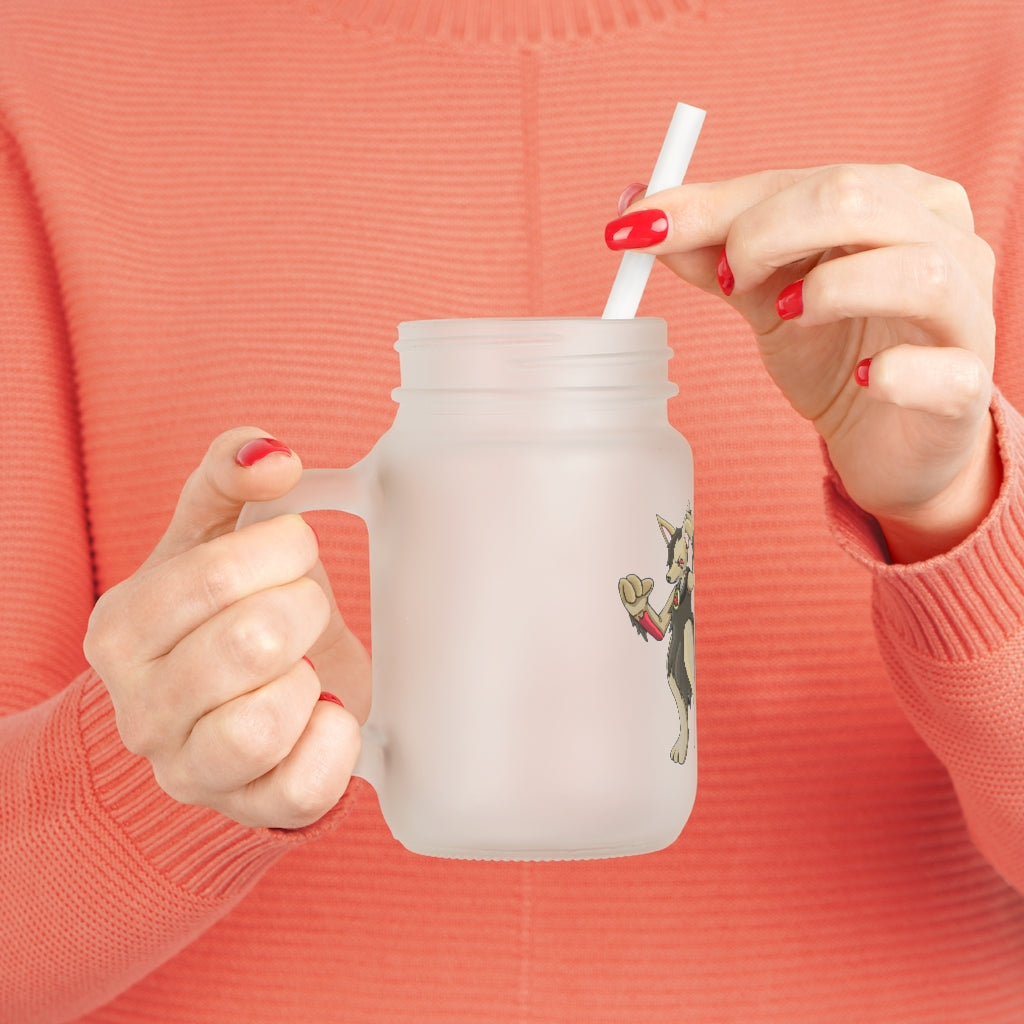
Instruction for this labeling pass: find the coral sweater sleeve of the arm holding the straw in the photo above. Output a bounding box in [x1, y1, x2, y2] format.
[825, 393, 1024, 892]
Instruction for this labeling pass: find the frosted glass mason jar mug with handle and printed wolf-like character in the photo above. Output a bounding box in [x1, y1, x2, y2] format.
[240, 318, 696, 860]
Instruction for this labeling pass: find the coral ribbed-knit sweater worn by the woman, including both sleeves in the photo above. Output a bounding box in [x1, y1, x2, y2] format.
[0, 0, 1024, 1024]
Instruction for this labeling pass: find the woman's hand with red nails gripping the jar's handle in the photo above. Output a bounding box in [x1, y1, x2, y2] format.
[85, 428, 370, 828]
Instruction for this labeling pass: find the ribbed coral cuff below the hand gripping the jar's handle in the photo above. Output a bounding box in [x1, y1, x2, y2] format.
[79, 672, 351, 902]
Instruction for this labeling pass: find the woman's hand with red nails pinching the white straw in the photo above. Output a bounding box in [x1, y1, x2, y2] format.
[606, 166, 1001, 561]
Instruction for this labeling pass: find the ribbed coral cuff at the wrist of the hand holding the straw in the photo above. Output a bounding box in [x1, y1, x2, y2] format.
[825, 392, 1024, 660]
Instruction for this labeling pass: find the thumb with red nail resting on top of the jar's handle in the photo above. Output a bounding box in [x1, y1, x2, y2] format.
[145, 427, 302, 565]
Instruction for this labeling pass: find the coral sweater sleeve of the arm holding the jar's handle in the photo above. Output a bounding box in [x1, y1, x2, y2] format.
[0, 133, 345, 1024]
